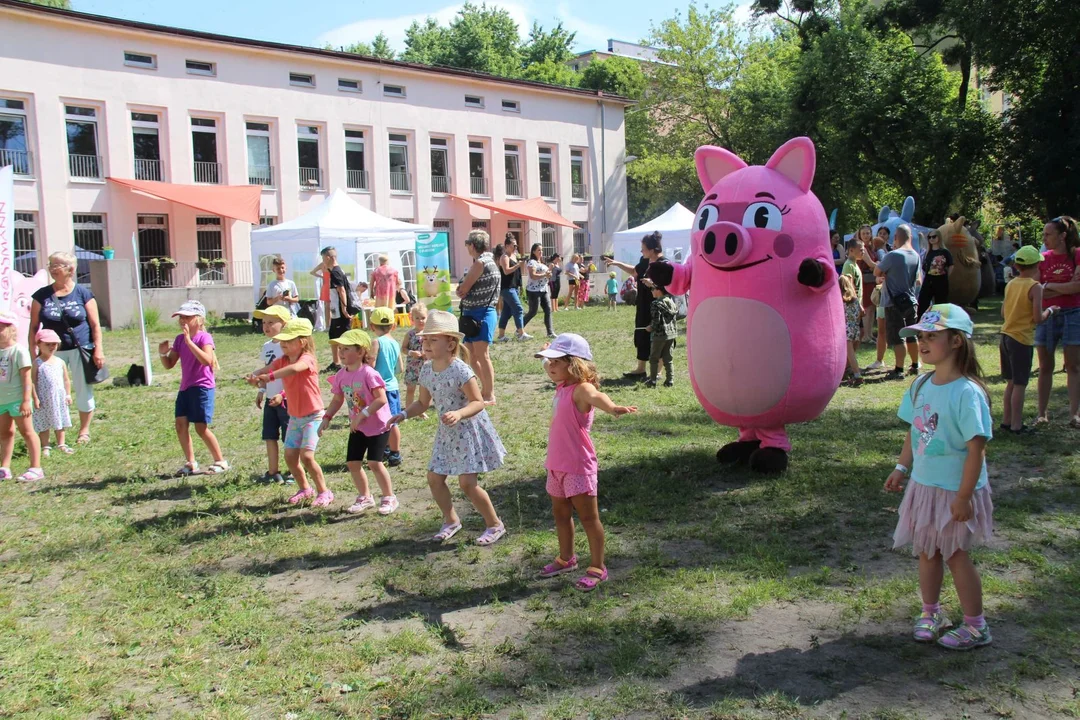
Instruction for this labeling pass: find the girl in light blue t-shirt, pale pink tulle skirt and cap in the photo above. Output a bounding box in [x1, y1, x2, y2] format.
[885, 303, 994, 650]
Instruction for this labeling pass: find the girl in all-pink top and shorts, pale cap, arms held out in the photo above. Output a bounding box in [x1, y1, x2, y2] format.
[536, 332, 637, 593]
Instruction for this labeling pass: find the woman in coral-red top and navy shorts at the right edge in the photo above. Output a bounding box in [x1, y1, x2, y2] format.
[1035, 216, 1080, 429]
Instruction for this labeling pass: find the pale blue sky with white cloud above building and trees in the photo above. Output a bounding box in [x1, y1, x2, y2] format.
[71, 0, 751, 52]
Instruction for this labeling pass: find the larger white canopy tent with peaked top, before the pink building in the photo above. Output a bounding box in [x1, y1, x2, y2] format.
[252, 189, 431, 302]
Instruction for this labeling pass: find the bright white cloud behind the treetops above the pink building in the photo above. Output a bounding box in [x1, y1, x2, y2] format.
[315, 0, 617, 52]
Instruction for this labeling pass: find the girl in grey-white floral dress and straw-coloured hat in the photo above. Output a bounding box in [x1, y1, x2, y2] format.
[390, 310, 507, 545]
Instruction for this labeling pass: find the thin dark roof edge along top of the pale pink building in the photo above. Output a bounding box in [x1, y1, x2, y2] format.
[0, 0, 634, 105]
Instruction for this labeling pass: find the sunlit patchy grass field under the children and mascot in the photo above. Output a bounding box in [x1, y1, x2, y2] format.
[0, 297, 1080, 720]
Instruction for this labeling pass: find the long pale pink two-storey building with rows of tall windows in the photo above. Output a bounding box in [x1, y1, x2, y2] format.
[0, 0, 629, 321]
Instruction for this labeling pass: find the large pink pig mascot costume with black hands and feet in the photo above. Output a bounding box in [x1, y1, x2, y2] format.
[654, 137, 846, 473]
